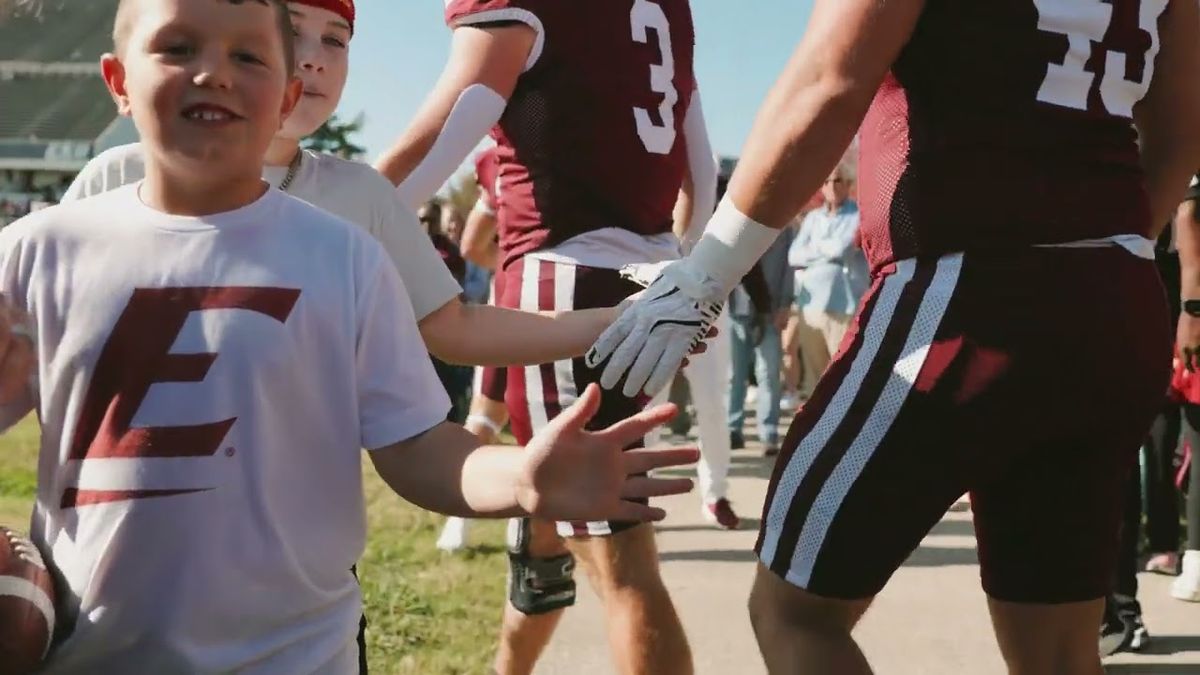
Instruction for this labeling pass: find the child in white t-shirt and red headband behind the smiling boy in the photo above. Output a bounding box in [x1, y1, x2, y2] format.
[64, 0, 616, 366]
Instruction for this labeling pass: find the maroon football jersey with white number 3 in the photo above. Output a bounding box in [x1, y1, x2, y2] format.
[446, 0, 696, 265]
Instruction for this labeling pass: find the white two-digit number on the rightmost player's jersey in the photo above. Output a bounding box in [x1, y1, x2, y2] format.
[1033, 0, 1169, 118]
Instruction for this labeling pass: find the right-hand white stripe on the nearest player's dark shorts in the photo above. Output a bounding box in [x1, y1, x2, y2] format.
[787, 253, 962, 589]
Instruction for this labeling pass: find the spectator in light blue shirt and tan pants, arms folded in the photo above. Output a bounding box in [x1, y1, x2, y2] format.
[785, 162, 868, 393]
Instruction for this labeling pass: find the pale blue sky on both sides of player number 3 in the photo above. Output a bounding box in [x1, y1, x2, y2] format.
[338, 0, 812, 160]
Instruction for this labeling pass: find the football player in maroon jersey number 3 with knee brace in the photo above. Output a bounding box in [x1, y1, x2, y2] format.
[377, 0, 716, 674]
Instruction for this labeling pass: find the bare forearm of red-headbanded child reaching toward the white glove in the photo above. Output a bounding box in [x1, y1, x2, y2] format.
[421, 303, 617, 366]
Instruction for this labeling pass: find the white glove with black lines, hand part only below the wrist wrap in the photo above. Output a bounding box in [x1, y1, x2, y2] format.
[584, 261, 728, 398]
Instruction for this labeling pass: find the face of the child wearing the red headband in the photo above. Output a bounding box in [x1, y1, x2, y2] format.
[280, 2, 352, 139]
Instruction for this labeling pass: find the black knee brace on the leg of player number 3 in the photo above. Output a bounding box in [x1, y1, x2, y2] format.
[509, 518, 575, 615]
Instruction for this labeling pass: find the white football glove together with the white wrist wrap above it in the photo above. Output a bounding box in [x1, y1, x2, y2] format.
[584, 197, 779, 398]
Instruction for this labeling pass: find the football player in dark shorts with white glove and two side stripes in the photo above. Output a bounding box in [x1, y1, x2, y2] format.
[595, 0, 1200, 674]
